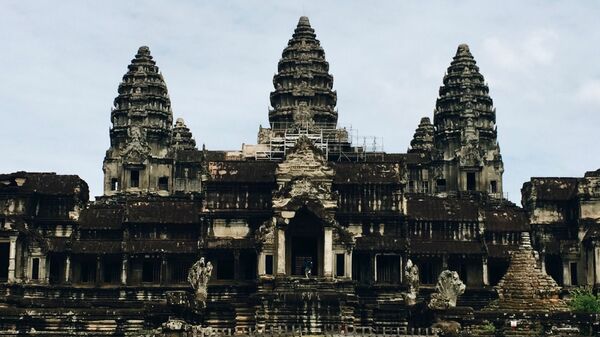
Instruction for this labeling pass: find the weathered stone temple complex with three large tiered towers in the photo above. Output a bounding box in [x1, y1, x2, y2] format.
[0, 17, 600, 336]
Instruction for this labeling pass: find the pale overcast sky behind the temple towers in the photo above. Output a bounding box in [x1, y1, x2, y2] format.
[0, 0, 600, 203]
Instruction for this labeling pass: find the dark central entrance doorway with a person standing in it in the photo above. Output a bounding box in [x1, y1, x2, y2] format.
[286, 209, 323, 276]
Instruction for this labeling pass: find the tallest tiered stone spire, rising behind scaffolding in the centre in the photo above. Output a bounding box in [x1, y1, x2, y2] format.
[269, 16, 337, 129]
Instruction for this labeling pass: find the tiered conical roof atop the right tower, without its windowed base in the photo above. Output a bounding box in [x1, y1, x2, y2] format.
[434, 44, 496, 140]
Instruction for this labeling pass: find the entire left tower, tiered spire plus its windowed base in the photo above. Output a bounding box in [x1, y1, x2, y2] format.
[103, 46, 173, 195]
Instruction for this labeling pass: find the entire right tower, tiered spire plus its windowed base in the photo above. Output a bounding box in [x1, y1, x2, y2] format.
[433, 44, 504, 196]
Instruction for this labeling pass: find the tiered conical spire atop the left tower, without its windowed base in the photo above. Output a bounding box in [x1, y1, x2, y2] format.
[110, 46, 173, 155]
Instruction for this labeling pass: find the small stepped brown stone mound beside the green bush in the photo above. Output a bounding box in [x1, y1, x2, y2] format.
[488, 232, 568, 312]
